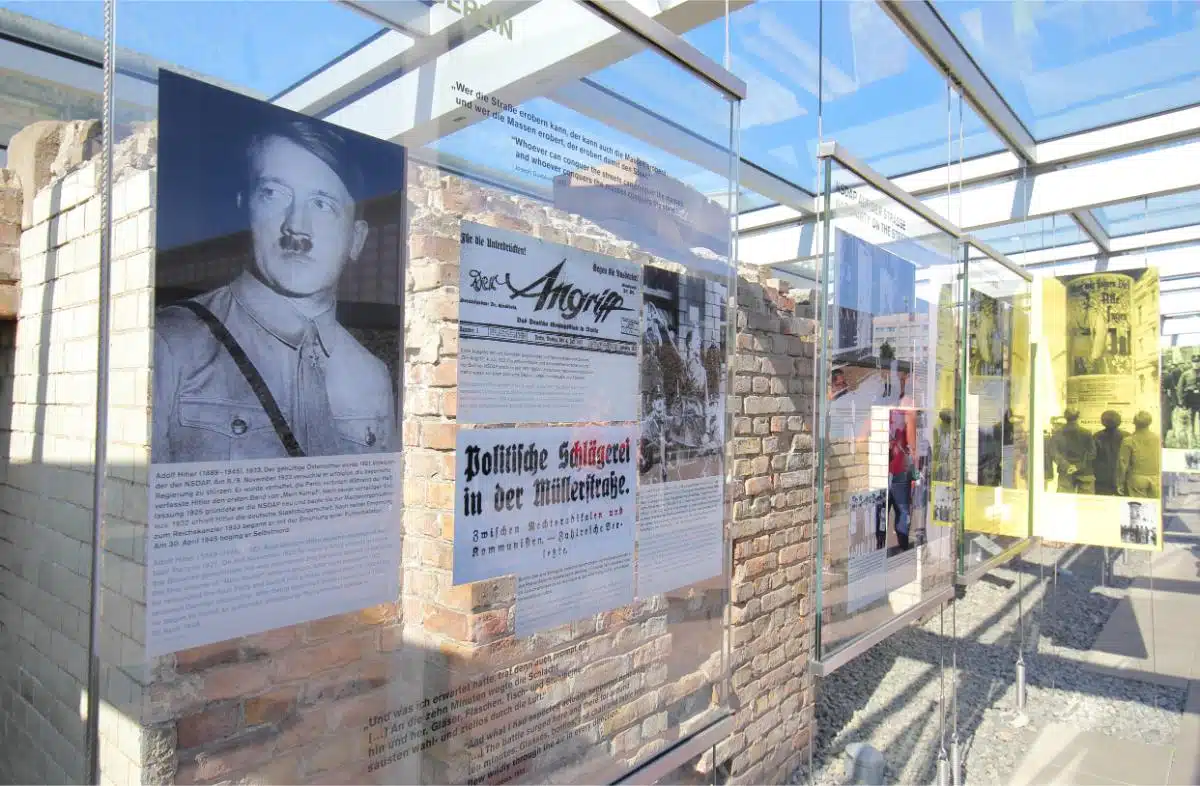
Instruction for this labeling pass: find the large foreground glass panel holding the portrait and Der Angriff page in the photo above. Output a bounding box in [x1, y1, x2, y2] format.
[93, 0, 737, 782]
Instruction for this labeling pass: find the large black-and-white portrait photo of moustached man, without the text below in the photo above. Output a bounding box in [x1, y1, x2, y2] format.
[151, 72, 406, 463]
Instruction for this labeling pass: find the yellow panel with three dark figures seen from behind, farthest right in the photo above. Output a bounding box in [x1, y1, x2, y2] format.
[1033, 268, 1174, 551]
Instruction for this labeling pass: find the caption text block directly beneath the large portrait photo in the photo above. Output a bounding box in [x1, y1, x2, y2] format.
[146, 454, 402, 658]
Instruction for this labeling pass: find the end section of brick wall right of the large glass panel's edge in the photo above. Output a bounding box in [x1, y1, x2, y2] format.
[716, 271, 816, 784]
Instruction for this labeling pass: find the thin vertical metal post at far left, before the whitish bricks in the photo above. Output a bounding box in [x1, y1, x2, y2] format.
[84, 0, 116, 784]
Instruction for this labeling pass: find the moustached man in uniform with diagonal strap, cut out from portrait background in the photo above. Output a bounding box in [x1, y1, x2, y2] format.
[152, 120, 397, 462]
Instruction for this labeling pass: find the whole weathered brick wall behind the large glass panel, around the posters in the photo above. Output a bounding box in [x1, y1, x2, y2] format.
[0, 120, 814, 786]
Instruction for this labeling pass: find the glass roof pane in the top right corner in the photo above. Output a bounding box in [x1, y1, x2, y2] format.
[934, 0, 1200, 140]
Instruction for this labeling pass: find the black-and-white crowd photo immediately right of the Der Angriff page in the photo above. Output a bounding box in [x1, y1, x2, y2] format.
[638, 266, 726, 482]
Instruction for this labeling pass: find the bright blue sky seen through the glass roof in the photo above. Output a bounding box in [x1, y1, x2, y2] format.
[0, 0, 1200, 211]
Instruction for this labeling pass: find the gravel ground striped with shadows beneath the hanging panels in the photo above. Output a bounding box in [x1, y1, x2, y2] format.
[792, 546, 1184, 786]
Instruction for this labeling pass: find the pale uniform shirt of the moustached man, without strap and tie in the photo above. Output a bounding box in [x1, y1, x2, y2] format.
[151, 274, 398, 462]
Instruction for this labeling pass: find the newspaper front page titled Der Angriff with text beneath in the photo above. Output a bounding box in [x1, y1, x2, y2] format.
[458, 222, 642, 424]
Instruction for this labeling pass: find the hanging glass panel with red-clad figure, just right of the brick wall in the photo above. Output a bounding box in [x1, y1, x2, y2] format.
[817, 160, 961, 658]
